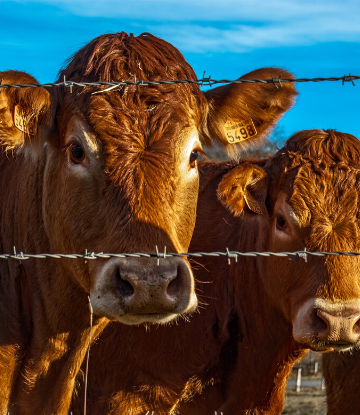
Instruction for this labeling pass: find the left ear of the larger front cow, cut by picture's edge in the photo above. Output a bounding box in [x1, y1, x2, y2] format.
[0, 71, 50, 150]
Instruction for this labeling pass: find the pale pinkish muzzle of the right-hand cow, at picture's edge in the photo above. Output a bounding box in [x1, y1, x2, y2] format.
[293, 299, 360, 351]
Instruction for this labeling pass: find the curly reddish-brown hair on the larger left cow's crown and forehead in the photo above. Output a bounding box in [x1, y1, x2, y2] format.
[54, 32, 207, 216]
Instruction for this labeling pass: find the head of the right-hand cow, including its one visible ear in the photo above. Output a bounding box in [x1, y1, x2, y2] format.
[219, 130, 360, 351]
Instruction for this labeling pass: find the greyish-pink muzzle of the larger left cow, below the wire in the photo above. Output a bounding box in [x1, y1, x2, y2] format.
[90, 258, 197, 324]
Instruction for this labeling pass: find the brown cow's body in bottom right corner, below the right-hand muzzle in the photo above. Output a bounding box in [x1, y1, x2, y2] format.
[322, 352, 360, 415]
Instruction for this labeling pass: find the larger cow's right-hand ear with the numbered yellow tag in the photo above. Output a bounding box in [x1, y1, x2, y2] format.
[201, 68, 297, 158]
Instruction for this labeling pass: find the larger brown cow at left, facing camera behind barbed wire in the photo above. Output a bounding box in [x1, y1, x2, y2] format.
[0, 33, 296, 415]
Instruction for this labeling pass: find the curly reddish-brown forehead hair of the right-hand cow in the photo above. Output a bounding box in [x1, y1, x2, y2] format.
[268, 130, 360, 250]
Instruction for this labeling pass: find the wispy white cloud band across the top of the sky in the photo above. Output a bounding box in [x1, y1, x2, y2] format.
[4, 0, 360, 53]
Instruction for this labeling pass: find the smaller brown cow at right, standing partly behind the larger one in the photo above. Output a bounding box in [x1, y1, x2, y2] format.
[74, 130, 360, 415]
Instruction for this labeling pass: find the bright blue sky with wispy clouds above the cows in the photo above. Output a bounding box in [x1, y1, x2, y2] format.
[0, 0, 360, 138]
